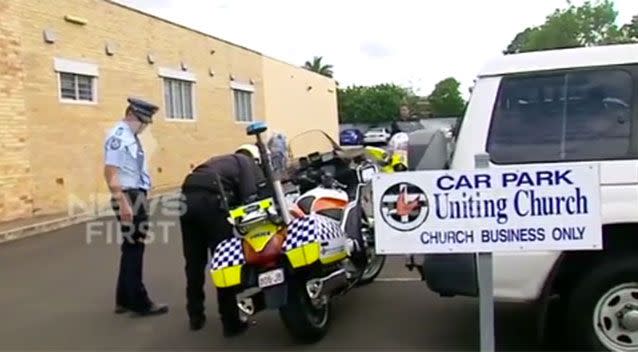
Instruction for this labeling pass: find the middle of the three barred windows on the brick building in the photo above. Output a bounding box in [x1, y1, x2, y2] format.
[164, 78, 195, 120]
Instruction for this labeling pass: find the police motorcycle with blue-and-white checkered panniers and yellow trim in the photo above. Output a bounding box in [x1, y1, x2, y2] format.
[210, 122, 365, 343]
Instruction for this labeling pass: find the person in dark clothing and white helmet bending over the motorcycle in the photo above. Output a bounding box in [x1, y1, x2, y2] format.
[180, 144, 265, 337]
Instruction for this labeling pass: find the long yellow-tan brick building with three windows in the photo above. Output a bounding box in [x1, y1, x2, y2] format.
[0, 0, 338, 222]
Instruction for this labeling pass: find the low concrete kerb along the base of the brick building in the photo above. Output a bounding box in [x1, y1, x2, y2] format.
[0, 190, 179, 244]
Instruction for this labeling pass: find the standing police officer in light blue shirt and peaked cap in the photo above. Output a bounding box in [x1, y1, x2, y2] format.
[104, 98, 168, 315]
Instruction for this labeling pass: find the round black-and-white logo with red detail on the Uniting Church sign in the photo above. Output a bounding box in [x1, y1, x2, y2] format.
[381, 182, 430, 231]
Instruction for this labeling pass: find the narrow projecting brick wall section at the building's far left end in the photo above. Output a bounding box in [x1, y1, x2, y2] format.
[0, 0, 33, 220]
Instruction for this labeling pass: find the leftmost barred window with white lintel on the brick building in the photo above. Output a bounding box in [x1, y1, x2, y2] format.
[54, 58, 98, 104]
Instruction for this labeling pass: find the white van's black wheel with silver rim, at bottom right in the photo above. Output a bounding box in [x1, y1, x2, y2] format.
[565, 254, 638, 351]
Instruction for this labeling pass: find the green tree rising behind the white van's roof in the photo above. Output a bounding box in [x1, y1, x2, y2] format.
[504, 0, 633, 54]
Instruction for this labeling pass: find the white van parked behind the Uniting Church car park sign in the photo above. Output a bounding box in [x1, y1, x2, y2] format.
[408, 44, 638, 351]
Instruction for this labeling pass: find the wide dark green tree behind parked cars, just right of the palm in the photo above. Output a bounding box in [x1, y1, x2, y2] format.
[337, 84, 414, 123]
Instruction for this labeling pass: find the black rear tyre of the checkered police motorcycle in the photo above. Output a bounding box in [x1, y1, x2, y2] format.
[279, 282, 332, 344]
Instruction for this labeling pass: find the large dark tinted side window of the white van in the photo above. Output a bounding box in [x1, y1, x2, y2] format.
[487, 69, 638, 164]
